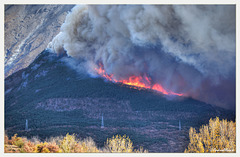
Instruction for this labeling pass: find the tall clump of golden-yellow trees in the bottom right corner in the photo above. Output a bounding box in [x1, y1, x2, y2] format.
[184, 117, 236, 153]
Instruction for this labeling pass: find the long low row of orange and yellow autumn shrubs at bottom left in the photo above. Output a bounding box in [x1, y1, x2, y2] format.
[4, 134, 148, 153]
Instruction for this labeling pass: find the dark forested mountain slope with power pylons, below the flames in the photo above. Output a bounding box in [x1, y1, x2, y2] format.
[5, 50, 235, 152]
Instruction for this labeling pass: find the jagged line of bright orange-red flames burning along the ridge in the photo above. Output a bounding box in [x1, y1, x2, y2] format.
[95, 64, 184, 96]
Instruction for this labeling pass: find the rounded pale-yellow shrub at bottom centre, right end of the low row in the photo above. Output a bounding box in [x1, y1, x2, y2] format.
[105, 135, 133, 153]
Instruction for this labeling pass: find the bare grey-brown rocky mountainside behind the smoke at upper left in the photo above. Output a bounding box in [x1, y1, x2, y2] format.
[4, 5, 73, 78]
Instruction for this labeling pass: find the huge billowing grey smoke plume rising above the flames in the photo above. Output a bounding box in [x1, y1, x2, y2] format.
[49, 5, 236, 108]
